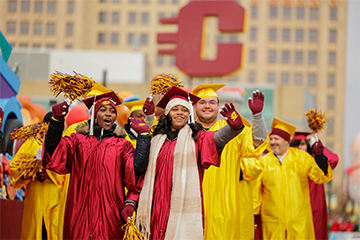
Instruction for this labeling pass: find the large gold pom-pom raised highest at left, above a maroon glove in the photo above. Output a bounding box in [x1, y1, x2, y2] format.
[48, 71, 95, 103]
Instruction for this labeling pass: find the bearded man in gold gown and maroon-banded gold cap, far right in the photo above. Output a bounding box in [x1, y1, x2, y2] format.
[255, 118, 333, 239]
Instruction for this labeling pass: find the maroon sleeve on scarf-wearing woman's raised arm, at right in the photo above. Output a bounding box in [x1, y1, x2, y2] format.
[196, 131, 221, 169]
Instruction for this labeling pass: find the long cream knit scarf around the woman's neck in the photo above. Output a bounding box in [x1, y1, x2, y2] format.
[136, 125, 204, 240]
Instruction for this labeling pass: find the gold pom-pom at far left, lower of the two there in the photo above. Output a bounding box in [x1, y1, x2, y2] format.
[13, 153, 41, 180]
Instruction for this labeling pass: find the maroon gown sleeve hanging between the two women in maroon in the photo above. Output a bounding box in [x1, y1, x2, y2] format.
[123, 141, 144, 202]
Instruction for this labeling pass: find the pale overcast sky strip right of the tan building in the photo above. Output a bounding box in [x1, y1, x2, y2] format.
[344, 0, 360, 169]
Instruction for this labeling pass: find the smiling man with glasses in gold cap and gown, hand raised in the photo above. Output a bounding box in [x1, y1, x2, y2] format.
[192, 84, 268, 239]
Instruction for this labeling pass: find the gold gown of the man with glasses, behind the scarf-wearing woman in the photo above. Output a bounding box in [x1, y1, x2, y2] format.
[203, 118, 268, 239]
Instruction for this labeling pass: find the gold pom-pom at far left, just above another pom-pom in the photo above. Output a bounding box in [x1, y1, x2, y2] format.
[10, 122, 48, 141]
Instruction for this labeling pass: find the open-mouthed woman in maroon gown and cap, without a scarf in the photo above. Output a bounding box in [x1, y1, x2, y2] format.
[43, 92, 151, 239]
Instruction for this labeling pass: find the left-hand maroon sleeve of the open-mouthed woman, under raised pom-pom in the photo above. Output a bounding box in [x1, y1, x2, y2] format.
[42, 134, 77, 174]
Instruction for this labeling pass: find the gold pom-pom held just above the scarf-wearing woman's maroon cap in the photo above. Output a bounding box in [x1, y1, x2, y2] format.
[150, 73, 184, 95]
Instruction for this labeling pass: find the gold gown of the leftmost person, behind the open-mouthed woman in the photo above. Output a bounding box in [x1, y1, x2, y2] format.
[10, 140, 66, 239]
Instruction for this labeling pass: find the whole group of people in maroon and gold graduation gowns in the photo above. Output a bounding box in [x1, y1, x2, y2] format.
[0, 79, 352, 239]
